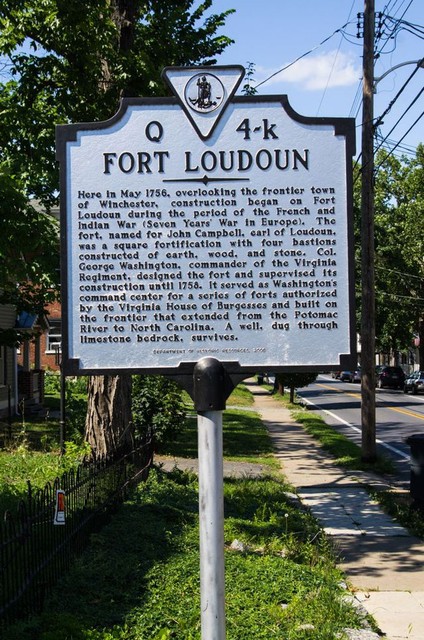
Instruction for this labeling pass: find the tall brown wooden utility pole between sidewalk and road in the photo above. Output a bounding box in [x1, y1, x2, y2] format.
[361, 0, 377, 462]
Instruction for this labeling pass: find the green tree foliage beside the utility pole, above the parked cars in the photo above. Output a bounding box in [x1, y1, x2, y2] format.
[356, 145, 424, 368]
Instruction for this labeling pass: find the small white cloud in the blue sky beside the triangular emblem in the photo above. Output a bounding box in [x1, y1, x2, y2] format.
[255, 50, 362, 91]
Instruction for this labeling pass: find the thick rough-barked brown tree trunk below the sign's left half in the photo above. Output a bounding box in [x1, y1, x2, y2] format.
[85, 374, 133, 458]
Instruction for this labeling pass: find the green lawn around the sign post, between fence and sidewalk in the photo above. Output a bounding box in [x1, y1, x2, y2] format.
[2, 382, 372, 640]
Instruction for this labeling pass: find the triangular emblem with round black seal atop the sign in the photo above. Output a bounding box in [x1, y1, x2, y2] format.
[162, 65, 245, 140]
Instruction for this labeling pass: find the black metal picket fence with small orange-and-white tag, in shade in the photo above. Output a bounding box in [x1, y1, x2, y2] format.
[0, 436, 153, 632]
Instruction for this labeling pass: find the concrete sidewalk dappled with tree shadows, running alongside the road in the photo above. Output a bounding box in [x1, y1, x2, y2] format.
[247, 381, 424, 640]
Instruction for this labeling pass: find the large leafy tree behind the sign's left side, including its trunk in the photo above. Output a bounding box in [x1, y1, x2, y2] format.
[0, 0, 235, 454]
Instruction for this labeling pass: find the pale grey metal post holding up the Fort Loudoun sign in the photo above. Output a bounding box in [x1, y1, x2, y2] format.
[197, 411, 225, 640]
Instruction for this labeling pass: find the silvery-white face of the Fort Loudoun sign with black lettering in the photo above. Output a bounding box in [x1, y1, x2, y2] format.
[56, 69, 354, 372]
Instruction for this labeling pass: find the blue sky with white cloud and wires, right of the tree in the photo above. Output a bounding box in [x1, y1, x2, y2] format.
[205, 0, 424, 155]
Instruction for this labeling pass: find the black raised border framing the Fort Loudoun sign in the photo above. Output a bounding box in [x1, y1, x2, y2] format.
[56, 87, 357, 392]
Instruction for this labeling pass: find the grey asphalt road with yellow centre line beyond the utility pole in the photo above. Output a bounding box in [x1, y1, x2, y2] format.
[298, 375, 424, 484]
